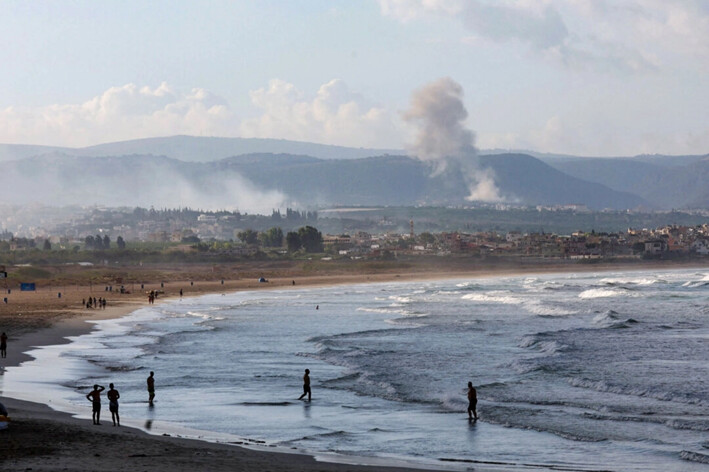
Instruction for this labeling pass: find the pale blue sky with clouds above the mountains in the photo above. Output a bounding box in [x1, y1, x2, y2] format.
[0, 0, 709, 156]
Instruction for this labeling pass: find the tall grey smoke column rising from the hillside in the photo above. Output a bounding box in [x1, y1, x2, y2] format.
[403, 77, 502, 202]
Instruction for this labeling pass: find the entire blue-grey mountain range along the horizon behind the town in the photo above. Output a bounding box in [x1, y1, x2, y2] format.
[0, 136, 709, 211]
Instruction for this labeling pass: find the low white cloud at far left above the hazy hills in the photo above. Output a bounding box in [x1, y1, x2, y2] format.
[0, 83, 235, 146]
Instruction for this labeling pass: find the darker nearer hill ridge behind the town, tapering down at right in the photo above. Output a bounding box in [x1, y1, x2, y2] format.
[3, 152, 648, 211]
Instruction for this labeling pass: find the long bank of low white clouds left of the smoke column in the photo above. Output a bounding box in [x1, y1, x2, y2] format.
[0, 79, 401, 147]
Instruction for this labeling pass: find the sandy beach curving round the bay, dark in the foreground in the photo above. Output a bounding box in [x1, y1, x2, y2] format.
[0, 264, 706, 471]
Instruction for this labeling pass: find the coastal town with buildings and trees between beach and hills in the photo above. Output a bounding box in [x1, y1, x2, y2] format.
[0, 204, 709, 259]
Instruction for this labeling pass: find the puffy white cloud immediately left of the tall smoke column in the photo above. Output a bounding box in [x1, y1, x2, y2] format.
[240, 79, 400, 147]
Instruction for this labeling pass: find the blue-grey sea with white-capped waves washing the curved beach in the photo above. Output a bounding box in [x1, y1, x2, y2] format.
[0, 269, 709, 472]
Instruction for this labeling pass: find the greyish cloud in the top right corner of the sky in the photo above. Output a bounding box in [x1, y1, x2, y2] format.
[379, 0, 709, 73]
